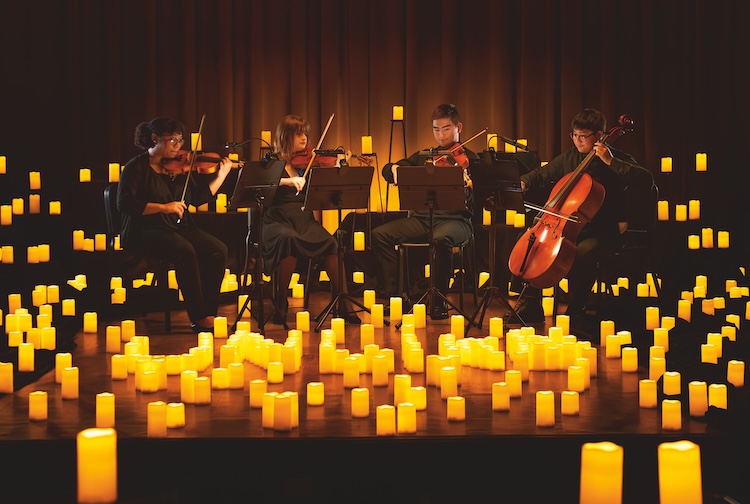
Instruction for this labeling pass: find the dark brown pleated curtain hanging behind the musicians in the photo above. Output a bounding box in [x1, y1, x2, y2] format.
[0, 0, 750, 250]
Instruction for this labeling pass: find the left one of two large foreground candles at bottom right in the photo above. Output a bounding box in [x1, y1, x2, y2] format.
[579, 441, 624, 504]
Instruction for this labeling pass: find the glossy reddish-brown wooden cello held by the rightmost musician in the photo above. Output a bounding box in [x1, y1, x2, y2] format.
[508, 115, 633, 289]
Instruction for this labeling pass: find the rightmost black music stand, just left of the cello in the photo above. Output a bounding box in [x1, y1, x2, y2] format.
[467, 151, 525, 330]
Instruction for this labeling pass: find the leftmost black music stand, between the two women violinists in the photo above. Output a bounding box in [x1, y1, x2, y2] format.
[227, 159, 289, 334]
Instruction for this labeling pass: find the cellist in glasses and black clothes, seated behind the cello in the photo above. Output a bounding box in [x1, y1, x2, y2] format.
[506, 108, 646, 323]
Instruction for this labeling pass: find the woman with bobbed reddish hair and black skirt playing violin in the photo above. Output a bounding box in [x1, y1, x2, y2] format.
[263, 115, 360, 324]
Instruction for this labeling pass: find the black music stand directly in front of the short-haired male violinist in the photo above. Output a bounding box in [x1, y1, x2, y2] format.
[396, 162, 472, 329]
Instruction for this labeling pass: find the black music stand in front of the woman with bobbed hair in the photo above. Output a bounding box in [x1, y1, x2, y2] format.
[302, 165, 382, 332]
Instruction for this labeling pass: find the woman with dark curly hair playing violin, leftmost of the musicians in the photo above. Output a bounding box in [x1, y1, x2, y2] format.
[117, 117, 232, 332]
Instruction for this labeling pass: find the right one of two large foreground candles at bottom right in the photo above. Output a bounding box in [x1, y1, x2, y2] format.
[658, 440, 703, 504]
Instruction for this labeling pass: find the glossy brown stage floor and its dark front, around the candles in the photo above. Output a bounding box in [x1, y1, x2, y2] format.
[0, 292, 750, 503]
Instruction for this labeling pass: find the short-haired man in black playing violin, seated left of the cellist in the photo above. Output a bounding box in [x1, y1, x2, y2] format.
[372, 103, 478, 320]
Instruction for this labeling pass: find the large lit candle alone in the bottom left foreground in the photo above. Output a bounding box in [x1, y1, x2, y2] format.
[76, 428, 117, 503]
